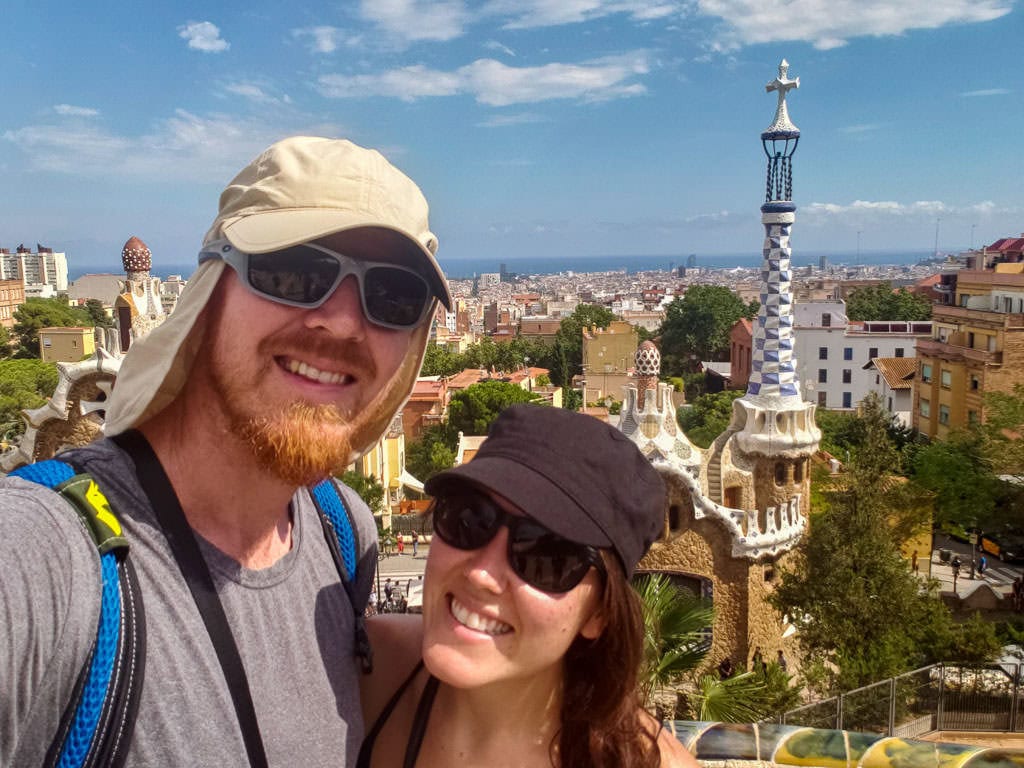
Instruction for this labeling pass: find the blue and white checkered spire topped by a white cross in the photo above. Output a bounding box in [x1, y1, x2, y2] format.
[746, 58, 800, 398]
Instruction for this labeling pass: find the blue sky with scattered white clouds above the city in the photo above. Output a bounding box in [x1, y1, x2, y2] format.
[0, 0, 1024, 272]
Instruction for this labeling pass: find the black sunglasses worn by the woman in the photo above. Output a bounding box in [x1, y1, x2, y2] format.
[432, 492, 604, 593]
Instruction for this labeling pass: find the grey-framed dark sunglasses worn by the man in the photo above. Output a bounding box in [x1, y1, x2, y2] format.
[199, 240, 434, 330]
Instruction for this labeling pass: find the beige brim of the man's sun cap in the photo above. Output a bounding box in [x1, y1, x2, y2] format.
[221, 208, 452, 309]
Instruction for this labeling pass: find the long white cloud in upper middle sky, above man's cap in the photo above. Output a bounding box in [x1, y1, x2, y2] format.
[319, 52, 648, 106]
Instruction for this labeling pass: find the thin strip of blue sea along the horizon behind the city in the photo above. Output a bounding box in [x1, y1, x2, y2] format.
[69, 250, 950, 281]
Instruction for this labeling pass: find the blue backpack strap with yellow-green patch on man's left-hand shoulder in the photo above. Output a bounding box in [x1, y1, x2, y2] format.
[10, 459, 145, 768]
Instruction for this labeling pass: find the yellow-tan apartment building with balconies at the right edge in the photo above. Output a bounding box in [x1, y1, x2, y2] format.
[913, 263, 1024, 439]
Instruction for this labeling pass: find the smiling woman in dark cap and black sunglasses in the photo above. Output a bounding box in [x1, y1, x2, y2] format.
[358, 406, 696, 768]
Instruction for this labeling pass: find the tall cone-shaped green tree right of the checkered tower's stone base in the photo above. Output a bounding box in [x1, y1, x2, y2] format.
[769, 403, 951, 693]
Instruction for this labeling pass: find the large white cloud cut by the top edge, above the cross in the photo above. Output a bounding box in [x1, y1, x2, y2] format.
[696, 0, 1013, 50]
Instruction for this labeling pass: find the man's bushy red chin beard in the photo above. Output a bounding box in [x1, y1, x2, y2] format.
[232, 402, 358, 487]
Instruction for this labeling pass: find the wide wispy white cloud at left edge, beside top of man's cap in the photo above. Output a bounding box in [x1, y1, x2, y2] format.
[0, 110, 341, 183]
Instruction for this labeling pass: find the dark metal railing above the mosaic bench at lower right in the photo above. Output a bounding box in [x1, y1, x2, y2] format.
[777, 664, 1024, 738]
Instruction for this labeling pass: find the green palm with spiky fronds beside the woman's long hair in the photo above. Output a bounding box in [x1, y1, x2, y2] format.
[634, 573, 766, 723]
